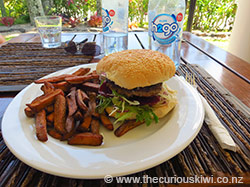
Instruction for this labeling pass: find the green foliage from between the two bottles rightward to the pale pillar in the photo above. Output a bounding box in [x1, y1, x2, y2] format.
[129, 0, 238, 31]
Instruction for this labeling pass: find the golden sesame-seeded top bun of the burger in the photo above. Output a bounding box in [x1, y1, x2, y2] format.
[96, 49, 175, 89]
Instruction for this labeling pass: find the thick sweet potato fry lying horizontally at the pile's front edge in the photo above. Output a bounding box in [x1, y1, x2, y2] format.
[68, 132, 103, 146]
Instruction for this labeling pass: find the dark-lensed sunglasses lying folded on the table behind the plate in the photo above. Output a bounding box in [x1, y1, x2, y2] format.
[64, 35, 101, 56]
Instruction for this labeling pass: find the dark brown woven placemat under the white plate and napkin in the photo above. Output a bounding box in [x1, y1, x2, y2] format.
[0, 64, 250, 186]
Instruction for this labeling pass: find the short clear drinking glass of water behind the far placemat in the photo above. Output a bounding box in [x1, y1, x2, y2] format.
[35, 16, 62, 48]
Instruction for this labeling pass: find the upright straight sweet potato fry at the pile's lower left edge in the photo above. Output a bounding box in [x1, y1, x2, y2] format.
[35, 110, 48, 142]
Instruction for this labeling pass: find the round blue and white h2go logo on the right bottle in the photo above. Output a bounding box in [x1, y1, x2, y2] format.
[151, 14, 181, 44]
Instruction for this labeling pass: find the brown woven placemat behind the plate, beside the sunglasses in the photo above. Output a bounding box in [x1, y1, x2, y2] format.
[0, 43, 93, 92]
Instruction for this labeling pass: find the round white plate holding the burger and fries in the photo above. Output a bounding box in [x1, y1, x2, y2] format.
[2, 64, 204, 179]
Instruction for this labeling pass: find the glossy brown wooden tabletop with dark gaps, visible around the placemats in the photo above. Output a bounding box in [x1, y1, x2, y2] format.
[2, 32, 250, 107]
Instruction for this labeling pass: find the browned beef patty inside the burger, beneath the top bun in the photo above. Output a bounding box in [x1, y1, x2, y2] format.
[107, 79, 162, 97]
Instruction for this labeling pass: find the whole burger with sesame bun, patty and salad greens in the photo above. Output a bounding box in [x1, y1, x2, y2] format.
[96, 49, 177, 125]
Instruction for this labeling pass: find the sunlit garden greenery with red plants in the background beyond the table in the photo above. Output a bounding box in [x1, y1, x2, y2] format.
[0, 0, 237, 48]
